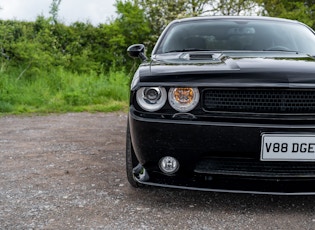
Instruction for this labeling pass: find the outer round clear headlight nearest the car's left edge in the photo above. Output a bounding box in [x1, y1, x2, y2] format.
[137, 87, 167, 112]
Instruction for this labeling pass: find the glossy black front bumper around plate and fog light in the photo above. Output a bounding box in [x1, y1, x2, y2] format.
[129, 110, 315, 195]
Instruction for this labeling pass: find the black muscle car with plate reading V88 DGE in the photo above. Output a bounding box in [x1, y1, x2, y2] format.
[126, 17, 315, 194]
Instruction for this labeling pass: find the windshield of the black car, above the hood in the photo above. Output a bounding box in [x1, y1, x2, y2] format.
[155, 19, 315, 56]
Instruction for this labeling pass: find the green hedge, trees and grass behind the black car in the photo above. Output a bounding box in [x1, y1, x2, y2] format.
[0, 0, 315, 114]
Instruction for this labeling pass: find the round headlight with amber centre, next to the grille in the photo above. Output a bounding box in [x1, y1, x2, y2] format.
[168, 87, 200, 113]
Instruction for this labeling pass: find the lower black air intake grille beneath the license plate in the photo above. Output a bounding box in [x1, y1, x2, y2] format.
[195, 158, 315, 178]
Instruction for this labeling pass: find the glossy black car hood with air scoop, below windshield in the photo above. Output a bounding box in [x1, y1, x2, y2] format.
[140, 52, 315, 84]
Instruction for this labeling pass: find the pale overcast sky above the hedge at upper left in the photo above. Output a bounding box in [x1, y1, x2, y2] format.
[0, 0, 116, 25]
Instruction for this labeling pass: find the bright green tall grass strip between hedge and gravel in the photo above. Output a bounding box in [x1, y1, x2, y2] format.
[0, 68, 129, 114]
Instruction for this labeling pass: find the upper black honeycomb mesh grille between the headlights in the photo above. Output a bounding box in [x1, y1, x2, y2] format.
[203, 89, 315, 114]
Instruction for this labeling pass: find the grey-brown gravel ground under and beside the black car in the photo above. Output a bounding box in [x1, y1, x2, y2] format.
[0, 113, 315, 229]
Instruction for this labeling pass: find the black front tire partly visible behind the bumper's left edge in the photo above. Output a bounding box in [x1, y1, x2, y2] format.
[126, 122, 142, 188]
